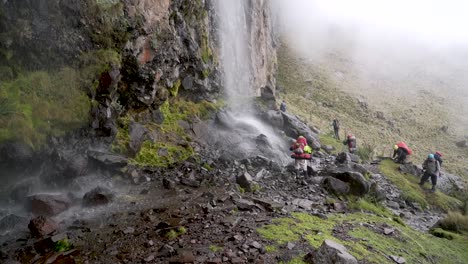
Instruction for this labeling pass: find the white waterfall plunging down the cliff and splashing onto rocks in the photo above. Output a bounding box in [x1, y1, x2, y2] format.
[216, 0, 289, 161]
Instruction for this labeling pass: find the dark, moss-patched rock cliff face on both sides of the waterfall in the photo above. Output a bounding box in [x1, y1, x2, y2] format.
[0, 0, 276, 188]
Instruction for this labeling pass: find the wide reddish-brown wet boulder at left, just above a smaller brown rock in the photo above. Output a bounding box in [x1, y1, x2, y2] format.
[27, 194, 71, 216]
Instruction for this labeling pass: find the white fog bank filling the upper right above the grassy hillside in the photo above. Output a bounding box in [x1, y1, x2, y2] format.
[273, 0, 468, 132]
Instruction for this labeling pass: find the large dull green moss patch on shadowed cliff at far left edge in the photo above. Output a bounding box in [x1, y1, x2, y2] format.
[0, 68, 90, 146]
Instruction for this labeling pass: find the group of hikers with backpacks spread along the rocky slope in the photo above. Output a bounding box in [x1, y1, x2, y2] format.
[286, 107, 442, 191]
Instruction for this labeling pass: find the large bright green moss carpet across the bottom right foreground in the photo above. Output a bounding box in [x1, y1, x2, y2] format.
[257, 213, 468, 263]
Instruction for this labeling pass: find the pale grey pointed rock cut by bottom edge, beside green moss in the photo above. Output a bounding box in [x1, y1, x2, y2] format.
[312, 239, 358, 264]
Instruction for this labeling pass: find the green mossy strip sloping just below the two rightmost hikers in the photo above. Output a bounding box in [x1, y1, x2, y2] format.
[379, 160, 463, 212]
